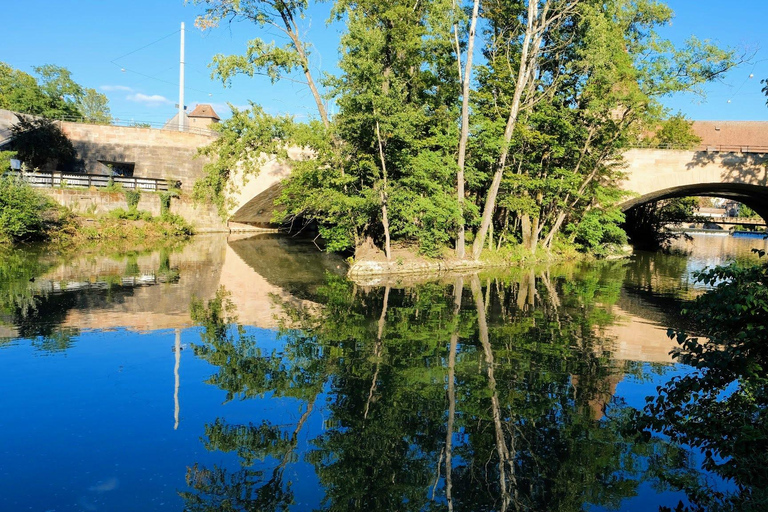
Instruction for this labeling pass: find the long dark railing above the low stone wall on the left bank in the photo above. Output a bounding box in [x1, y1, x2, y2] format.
[7, 171, 181, 192]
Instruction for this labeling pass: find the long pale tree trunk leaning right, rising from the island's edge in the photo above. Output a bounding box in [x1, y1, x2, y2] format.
[472, 0, 548, 259]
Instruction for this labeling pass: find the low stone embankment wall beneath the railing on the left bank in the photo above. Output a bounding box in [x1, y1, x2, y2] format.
[38, 188, 229, 233]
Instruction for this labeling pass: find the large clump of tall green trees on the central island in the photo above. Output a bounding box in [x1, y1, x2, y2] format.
[192, 0, 738, 261]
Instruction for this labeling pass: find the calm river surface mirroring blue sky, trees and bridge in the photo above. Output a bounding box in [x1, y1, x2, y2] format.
[0, 235, 766, 512]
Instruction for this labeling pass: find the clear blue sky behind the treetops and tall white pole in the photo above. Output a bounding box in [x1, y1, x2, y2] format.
[0, 0, 768, 122]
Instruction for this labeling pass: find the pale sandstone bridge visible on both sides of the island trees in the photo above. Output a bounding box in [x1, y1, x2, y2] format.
[0, 111, 768, 226]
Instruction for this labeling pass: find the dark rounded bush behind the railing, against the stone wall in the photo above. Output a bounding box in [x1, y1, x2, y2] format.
[11, 115, 82, 171]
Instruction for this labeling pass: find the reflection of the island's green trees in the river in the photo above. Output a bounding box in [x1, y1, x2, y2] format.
[180, 264, 674, 511]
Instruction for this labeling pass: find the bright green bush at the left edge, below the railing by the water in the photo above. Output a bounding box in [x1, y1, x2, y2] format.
[0, 176, 56, 243]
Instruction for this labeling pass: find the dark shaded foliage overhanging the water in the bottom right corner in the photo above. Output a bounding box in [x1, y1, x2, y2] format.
[644, 258, 768, 511]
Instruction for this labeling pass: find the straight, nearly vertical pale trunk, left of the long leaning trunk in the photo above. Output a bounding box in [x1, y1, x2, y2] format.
[454, 0, 480, 258]
